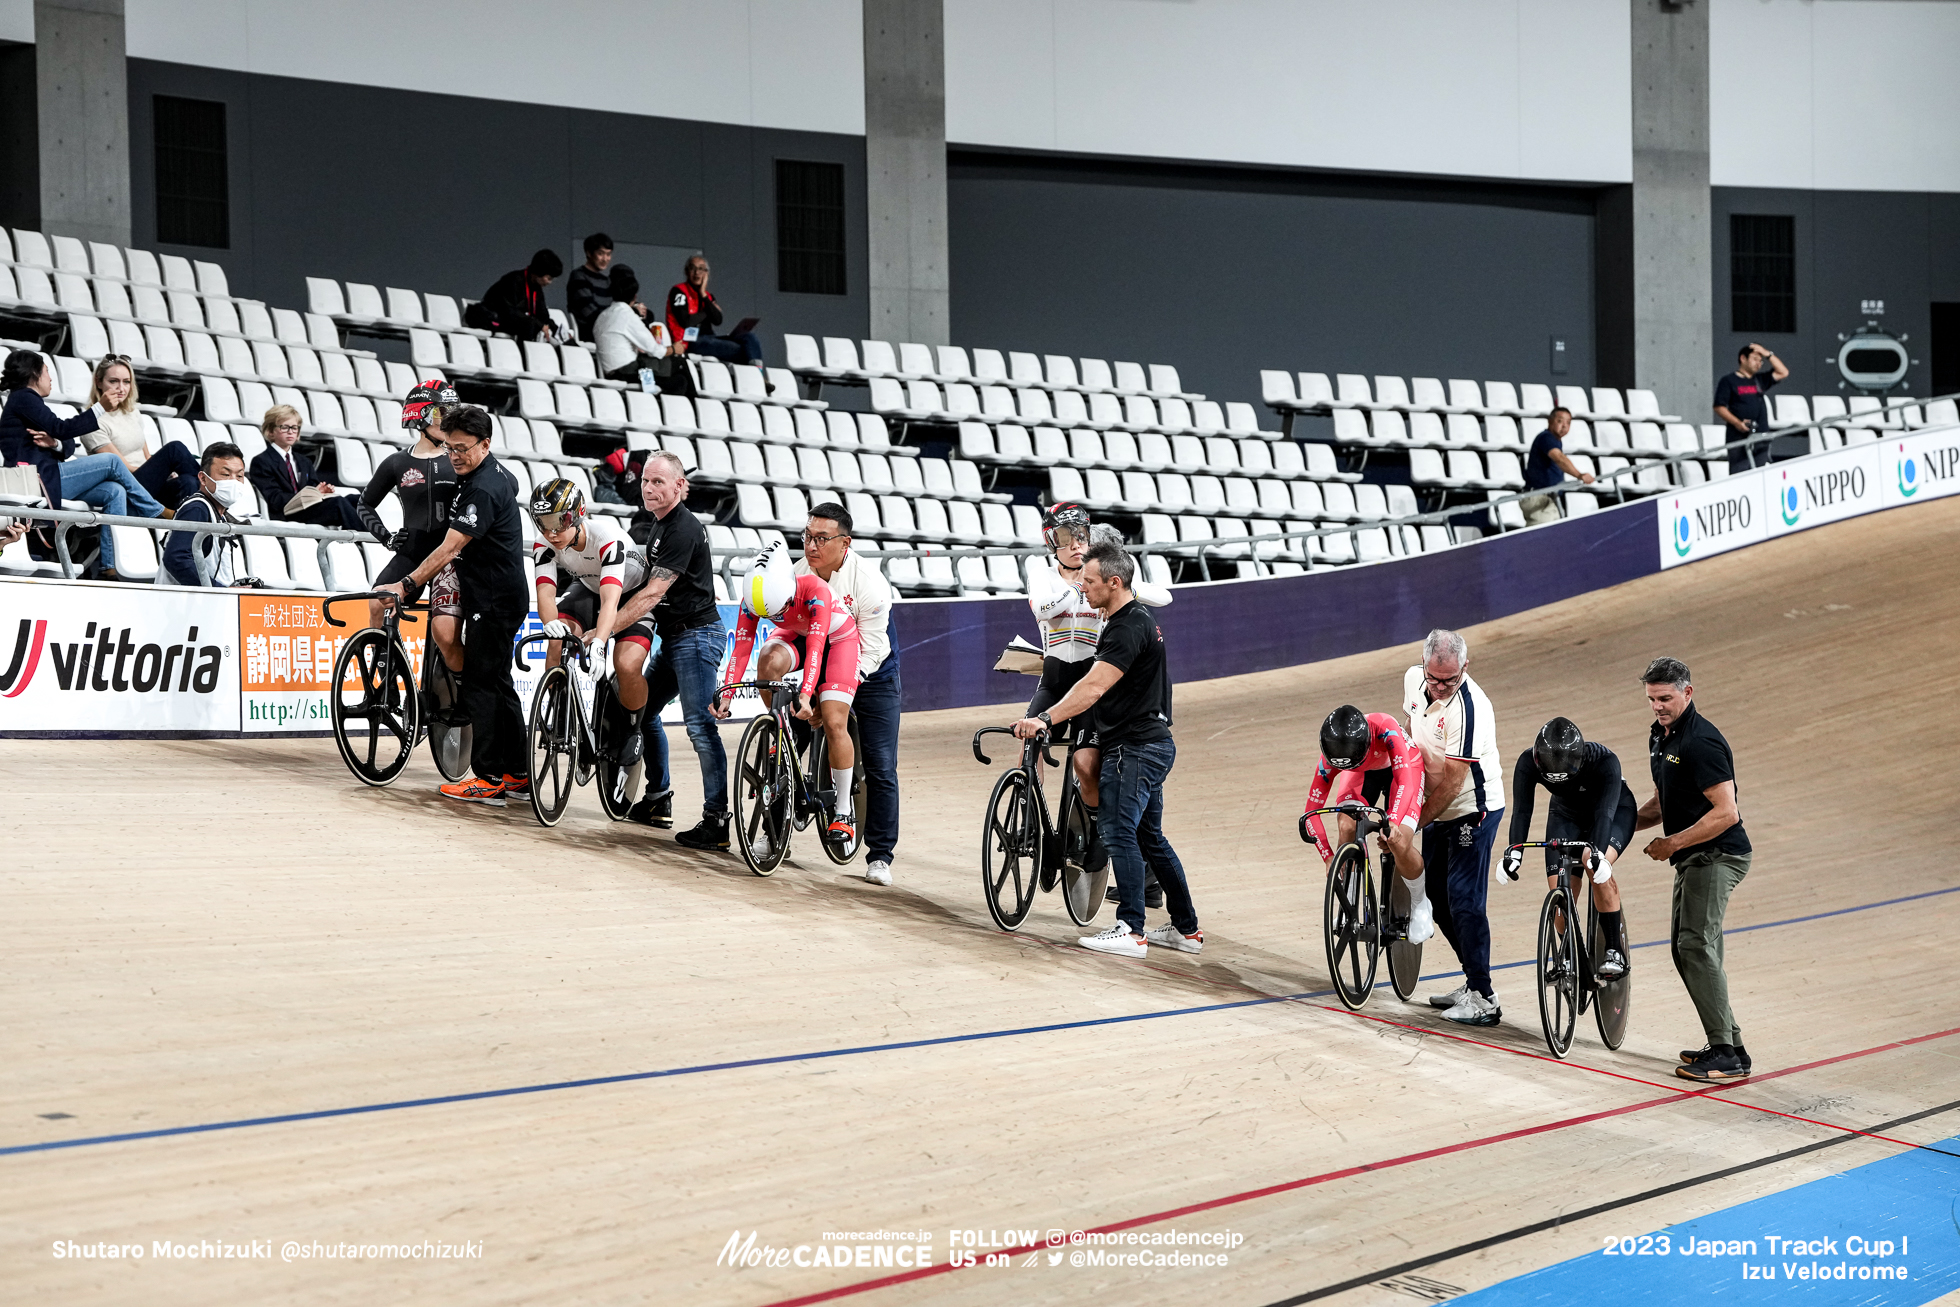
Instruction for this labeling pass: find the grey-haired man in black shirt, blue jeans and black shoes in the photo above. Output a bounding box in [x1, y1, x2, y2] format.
[619, 451, 729, 848]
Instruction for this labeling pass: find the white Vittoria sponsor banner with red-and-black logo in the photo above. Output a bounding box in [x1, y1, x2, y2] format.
[0, 578, 239, 735]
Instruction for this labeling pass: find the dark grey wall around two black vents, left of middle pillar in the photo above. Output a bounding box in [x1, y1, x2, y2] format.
[118, 59, 868, 361]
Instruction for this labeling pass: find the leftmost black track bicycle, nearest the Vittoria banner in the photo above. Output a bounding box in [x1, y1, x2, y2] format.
[319, 590, 470, 786]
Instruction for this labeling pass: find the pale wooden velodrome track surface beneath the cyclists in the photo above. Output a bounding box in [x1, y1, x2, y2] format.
[0, 500, 1960, 1307]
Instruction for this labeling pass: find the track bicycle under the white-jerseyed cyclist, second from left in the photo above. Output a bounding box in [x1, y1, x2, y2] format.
[512, 635, 645, 827]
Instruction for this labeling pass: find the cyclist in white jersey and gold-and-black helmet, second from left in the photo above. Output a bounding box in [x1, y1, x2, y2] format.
[527, 478, 653, 766]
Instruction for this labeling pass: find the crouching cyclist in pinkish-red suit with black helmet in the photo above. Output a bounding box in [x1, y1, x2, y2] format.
[1299, 703, 1437, 944]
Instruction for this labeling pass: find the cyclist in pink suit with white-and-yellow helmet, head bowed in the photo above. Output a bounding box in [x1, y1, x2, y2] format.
[713, 541, 858, 856]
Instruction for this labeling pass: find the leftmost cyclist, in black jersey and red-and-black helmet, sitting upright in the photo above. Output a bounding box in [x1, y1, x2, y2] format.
[355, 380, 463, 672]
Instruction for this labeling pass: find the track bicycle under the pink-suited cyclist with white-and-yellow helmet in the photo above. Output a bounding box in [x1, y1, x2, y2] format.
[715, 680, 864, 876]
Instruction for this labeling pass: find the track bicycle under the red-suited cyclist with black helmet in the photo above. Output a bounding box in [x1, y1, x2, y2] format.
[1307, 801, 1423, 1009]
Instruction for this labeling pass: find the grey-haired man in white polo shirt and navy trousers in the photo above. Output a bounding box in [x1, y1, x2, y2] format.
[1401, 631, 1503, 1025]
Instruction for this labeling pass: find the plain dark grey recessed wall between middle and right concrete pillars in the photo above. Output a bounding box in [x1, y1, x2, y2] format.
[947, 151, 1595, 398]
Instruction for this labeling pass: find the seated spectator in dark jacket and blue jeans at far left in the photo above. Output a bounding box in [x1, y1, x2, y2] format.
[0, 349, 169, 580]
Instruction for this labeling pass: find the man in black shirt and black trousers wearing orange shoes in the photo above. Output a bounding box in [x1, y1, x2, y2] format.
[374, 404, 531, 807]
